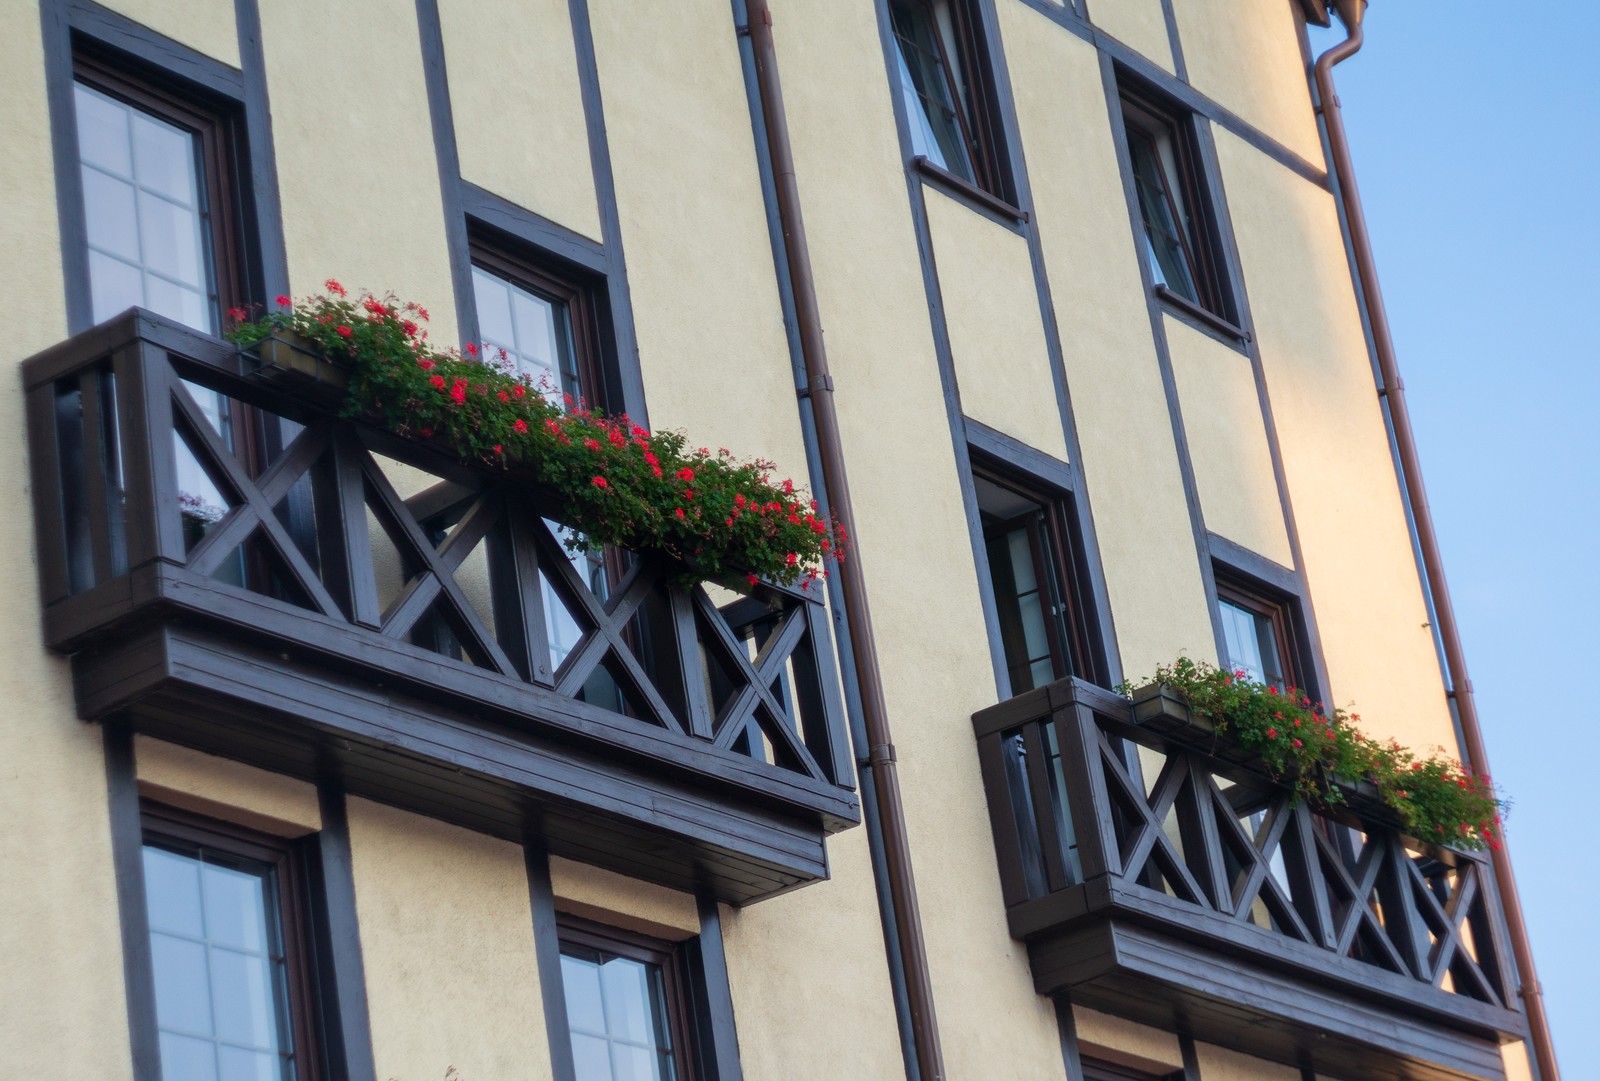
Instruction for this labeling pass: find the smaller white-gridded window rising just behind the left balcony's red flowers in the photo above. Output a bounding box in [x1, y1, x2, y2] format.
[472, 245, 606, 406]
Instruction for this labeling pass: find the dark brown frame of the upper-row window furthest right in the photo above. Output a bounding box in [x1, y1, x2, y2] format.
[1118, 80, 1243, 323]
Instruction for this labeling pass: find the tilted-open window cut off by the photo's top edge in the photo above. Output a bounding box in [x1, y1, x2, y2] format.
[890, 0, 1011, 198]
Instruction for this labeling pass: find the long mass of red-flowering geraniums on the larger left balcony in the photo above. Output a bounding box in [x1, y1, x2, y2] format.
[227, 278, 846, 588]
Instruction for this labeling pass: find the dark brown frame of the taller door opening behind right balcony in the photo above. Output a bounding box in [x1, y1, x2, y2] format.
[971, 449, 1106, 692]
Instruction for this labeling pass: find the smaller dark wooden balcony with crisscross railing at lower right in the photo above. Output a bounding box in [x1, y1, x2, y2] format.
[973, 680, 1525, 1081]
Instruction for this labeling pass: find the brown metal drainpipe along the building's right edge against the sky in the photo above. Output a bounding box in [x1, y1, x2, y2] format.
[1314, 0, 1562, 1081]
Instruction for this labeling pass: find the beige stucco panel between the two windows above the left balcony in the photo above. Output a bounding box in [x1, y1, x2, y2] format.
[261, 0, 456, 345]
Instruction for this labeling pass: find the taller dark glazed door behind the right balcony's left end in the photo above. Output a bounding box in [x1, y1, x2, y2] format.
[973, 465, 1098, 694]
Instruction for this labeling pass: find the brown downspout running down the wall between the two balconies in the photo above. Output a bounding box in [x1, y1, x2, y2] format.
[746, 0, 946, 1081]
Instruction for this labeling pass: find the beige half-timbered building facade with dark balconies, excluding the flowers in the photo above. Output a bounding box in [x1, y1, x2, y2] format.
[0, 0, 1557, 1081]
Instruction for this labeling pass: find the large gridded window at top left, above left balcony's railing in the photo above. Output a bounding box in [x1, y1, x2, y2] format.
[72, 49, 245, 334]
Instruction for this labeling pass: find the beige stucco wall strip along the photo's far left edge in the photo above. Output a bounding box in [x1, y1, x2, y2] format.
[0, 5, 133, 1081]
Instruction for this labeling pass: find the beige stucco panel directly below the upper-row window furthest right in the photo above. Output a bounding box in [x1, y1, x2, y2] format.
[1165, 317, 1294, 566]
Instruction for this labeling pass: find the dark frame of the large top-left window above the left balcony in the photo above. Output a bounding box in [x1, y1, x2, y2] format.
[70, 35, 251, 336]
